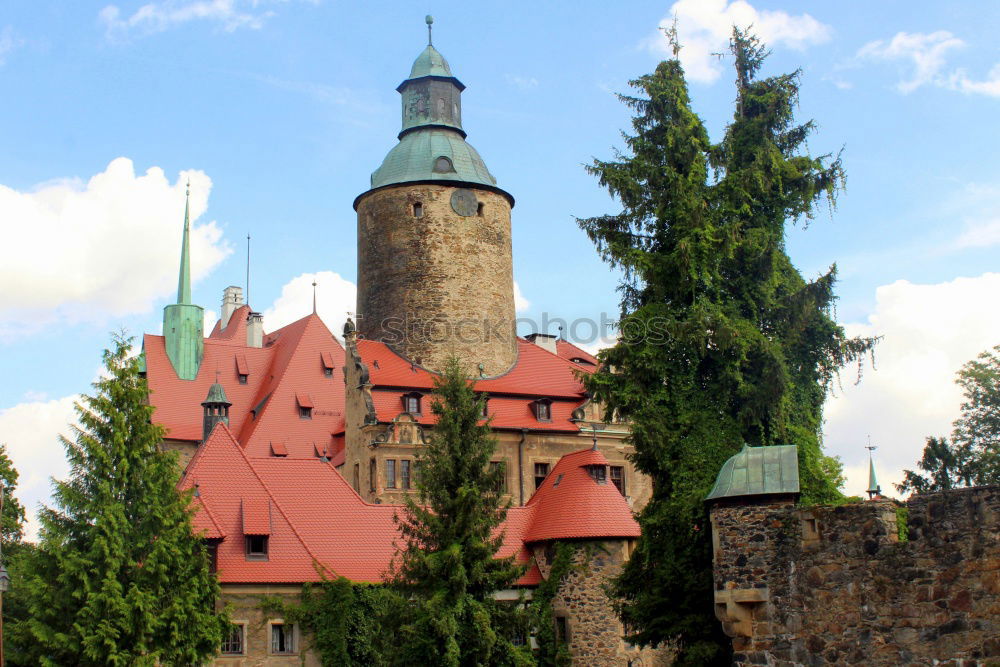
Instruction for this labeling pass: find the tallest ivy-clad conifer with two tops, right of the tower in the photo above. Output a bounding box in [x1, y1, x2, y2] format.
[579, 30, 875, 665]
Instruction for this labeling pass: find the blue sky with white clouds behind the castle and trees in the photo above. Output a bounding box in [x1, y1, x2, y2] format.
[0, 0, 1000, 532]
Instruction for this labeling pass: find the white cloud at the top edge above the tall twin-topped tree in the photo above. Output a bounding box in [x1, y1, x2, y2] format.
[643, 0, 831, 83]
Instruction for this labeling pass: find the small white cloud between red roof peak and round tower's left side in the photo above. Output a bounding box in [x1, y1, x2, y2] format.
[264, 271, 358, 338]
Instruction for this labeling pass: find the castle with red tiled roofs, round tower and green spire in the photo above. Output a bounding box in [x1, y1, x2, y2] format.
[143, 20, 668, 665]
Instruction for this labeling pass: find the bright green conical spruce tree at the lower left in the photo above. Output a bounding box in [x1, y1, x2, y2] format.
[22, 336, 227, 666]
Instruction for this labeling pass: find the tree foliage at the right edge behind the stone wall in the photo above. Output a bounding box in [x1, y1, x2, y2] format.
[896, 345, 1000, 493]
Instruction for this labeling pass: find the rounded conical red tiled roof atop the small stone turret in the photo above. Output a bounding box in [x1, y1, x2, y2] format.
[524, 449, 639, 542]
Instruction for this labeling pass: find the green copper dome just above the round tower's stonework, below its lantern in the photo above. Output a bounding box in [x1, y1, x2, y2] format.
[371, 128, 497, 189]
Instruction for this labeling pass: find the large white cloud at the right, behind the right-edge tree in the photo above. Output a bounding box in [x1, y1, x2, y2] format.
[824, 273, 1000, 494]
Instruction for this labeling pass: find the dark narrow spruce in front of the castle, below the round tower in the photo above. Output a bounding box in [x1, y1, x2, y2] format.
[392, 359, 530, 666]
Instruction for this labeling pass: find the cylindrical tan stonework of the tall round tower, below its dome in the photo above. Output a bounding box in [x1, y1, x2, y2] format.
[357, 184, 517, 375]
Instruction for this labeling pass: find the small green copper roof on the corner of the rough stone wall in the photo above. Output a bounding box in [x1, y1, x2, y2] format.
[705, 445, 799, 500]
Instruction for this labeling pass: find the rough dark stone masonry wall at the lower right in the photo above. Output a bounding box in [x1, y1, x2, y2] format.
[712, 487, 1000, 667]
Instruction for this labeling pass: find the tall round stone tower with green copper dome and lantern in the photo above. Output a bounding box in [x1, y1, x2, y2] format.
[354, 17, 517, 376]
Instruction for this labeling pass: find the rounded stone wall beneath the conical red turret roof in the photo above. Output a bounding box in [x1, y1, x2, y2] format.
[534, 540, 674, 667]
